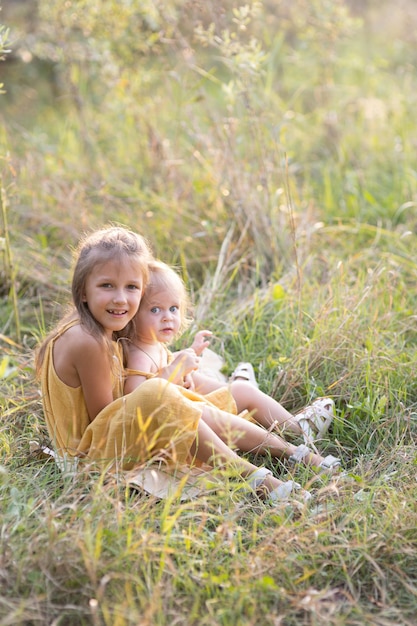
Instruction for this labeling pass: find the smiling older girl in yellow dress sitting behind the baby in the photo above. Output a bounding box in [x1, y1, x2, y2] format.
[36, 227, 316, 501]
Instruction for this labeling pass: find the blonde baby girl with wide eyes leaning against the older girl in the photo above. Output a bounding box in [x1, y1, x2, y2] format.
[125, 260, 340, 470]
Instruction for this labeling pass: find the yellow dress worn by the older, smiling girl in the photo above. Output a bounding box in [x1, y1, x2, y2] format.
[41, 321, 207, 470]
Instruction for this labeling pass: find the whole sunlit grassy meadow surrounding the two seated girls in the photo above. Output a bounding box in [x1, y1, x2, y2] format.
[0, 0, 417, 626]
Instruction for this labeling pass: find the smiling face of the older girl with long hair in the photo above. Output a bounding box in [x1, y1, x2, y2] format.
[83, 258, 143, 337]
